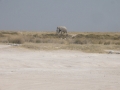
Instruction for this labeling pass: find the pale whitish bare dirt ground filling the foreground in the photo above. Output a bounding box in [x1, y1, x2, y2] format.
[0, 45, 120, 90]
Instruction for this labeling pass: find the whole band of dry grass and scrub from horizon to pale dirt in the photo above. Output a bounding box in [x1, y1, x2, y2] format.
[0, 31, 120, 53]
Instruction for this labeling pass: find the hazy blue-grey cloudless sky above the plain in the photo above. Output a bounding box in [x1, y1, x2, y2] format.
[0, 0, 120, 32]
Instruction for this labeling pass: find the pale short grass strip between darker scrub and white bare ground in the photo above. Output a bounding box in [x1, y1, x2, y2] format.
[22, 43, 120, 53]
